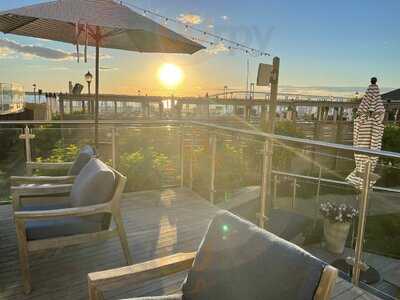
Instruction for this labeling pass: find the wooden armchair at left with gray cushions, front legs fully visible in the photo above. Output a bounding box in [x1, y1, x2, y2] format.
[13, 158, 132, 293]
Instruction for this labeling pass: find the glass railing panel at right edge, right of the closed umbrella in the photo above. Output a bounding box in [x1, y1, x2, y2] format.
[360, 158, 400, 299]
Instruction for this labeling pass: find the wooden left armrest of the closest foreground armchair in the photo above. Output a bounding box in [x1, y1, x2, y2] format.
[88, 252, 196, 300]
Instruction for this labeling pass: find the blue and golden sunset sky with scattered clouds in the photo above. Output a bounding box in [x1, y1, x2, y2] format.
[0, 0, 400, 95]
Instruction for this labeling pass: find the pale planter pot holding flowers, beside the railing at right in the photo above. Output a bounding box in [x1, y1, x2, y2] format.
[324, 220, 350, 254]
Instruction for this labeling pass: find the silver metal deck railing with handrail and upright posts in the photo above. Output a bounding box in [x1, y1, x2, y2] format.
[0, 120, 400, 296]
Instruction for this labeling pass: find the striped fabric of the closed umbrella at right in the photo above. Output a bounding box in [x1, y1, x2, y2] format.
[346, 84, 385, 190]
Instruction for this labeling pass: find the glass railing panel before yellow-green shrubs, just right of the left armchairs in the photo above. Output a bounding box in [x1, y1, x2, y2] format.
[117, 125, 181, 192]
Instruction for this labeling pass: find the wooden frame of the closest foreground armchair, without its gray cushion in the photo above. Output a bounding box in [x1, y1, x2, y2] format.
[88, 252, 338, 300]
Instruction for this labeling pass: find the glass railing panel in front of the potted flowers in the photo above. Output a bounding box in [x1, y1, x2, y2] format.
[270, 141, 358, 274]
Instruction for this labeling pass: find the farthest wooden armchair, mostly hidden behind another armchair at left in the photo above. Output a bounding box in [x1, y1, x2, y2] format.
[10, 146, 96, 186]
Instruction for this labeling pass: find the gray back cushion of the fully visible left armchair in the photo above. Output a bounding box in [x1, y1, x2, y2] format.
[70, 158, 115, 207]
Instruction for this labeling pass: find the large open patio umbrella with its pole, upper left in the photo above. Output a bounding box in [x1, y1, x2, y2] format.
[0, 0, 204, 144]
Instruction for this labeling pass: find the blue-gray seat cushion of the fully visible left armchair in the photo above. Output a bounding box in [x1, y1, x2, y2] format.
[21, 204, 101, 241]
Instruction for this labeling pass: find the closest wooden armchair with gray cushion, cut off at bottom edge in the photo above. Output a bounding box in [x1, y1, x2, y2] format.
[88, 212, 337, 300]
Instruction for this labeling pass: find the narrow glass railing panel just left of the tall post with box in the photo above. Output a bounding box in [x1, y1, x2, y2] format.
[214, 132, 264, 223]
